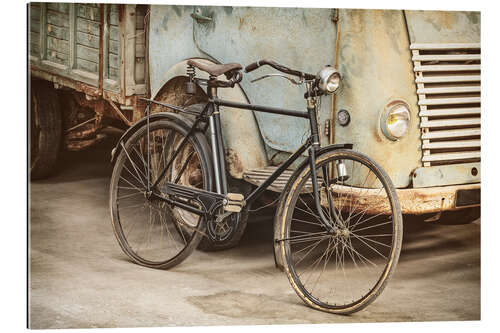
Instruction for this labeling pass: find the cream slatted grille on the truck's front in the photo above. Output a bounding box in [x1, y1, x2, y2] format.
[410, 43, 481, 167]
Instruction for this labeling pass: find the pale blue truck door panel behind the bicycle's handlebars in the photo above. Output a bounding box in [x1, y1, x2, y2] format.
[193, 7, 336, 152]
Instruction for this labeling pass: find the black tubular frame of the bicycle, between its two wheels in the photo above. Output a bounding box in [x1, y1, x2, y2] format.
[141, 81, 335, 231]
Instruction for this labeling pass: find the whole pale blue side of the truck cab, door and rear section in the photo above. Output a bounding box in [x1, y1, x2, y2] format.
[150, 6, 336, 152]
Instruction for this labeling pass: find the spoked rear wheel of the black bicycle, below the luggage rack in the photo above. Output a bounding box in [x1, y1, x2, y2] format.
[110, 120, 212, 269]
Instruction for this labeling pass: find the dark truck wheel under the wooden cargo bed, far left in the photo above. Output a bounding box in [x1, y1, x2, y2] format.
[30, 82, 62, 179]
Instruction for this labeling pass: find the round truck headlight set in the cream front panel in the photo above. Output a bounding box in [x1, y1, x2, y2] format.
[380, 101, 411, 141]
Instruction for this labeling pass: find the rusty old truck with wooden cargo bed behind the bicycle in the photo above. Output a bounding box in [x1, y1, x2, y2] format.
[28, 3, 481, 249]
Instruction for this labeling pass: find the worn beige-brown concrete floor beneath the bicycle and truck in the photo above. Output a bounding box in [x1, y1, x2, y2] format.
[29, 136, 480, 328]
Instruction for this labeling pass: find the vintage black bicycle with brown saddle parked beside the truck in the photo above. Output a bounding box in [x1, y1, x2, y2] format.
[110, 60, 403, 314]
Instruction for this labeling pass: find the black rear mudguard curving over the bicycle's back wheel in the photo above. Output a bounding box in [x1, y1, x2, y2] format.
[111, 104, 205, 165]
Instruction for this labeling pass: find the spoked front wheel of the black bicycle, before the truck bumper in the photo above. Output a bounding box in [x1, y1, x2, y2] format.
[275, 150, 403, 314]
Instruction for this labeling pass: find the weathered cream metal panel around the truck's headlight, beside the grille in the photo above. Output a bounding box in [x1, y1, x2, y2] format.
[333, 9, 421, 187]
